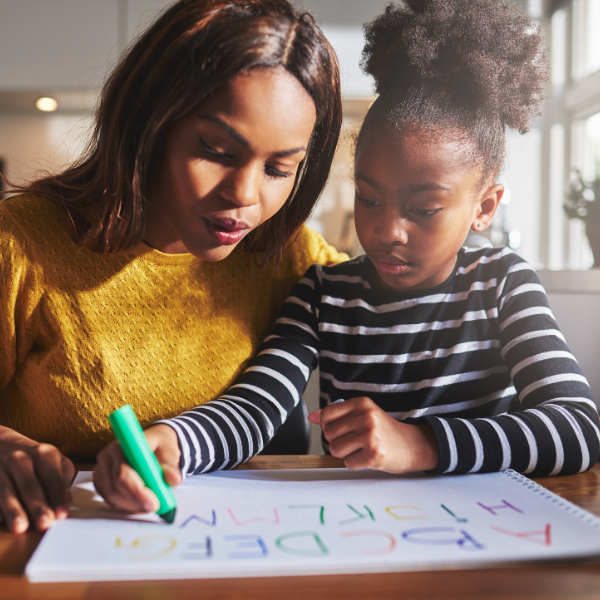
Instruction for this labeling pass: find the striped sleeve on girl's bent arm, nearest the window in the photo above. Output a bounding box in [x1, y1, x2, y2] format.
[428, 261, 600, 476]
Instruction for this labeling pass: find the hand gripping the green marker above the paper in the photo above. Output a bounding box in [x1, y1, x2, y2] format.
[94, 425, 183, 513]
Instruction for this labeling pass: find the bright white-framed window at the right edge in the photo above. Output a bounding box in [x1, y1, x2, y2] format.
[540, 0, 600, 269]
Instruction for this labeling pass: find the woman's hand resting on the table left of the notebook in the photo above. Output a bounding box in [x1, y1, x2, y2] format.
[0, 427, 75, 533]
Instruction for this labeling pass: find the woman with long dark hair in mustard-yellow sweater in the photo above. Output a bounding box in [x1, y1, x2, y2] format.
[0, 0, 341, 532]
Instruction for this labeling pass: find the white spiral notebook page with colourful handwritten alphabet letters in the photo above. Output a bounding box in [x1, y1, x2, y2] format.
[26, 469, 600, 581]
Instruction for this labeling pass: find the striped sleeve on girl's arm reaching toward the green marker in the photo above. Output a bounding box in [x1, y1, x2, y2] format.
[160, 265, 321, 474]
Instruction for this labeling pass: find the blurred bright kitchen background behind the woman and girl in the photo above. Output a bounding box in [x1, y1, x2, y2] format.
[0, 0, 600, 448]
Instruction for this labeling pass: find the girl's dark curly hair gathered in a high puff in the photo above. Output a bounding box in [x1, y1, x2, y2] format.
[357, 0, 549, 181]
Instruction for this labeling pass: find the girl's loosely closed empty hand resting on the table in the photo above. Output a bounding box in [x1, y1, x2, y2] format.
[308, 397, 440, 473]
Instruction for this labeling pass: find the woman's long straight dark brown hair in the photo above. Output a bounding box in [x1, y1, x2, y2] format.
[16, 0, 342, 262]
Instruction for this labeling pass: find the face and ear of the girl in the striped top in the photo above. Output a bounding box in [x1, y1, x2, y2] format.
[355, 129, 504, 292]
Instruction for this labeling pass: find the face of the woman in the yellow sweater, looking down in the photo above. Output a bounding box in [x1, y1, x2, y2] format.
[144, 67, 316, 261]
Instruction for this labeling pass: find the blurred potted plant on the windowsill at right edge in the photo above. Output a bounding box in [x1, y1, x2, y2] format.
[563, 171, 600, 268]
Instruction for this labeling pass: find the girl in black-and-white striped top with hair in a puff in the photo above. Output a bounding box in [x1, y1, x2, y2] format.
[97, 0, 599, 508]
